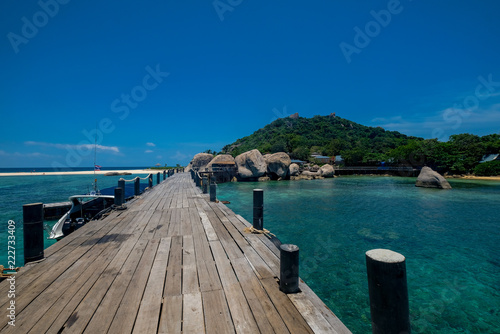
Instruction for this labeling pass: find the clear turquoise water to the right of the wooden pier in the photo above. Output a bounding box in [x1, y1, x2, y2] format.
[217, 176, 500, 333]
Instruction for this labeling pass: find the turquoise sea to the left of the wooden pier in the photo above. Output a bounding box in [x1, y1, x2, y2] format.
[0, 174, 149, 267]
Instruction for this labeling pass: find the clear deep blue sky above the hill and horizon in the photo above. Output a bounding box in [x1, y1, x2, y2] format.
[0, 0, 500, 167]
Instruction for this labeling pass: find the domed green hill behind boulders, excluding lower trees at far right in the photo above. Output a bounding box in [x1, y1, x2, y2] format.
[222, 115, 423, 164]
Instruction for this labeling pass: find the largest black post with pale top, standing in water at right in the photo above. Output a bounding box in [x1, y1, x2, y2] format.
[366, 249, 411, 334]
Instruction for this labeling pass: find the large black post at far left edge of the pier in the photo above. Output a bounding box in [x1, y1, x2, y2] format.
[23, 203, 44, 263]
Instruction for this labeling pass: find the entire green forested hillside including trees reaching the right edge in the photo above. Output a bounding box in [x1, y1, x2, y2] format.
[222, 114, 500, 175]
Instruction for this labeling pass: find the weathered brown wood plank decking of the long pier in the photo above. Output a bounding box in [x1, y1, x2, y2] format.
[0, 174, 350, 334]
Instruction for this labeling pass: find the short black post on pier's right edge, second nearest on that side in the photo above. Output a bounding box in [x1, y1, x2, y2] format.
[280, 244, 300, 293]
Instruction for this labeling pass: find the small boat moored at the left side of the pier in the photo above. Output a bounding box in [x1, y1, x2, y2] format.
[48, 192, 115, 240]
